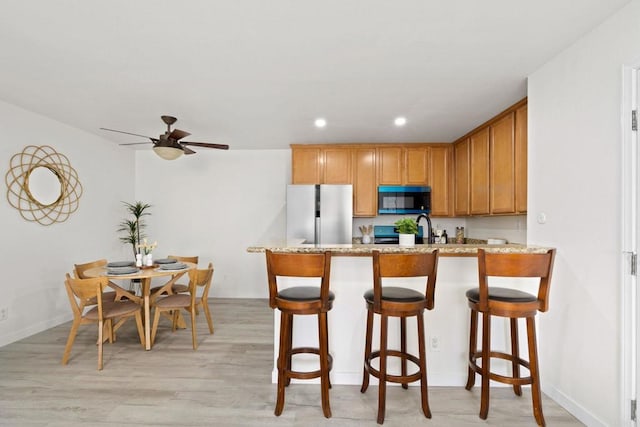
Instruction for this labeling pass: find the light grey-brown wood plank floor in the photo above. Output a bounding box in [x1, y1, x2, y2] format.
[0, 299, 582, 427]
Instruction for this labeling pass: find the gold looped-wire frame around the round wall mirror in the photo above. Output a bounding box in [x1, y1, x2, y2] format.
[5, 145, 82, 225]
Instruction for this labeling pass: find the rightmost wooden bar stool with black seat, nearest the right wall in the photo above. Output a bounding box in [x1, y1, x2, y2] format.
[465, 249, 555, 426]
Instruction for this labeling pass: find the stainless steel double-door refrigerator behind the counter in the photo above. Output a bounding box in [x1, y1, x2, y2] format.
[287, 185, 353, 245]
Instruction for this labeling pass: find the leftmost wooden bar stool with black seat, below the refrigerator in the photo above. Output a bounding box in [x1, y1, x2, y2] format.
[266, 250, 335, 418]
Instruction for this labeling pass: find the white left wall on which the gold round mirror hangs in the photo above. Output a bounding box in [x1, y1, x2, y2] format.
[0, 102, 134, 348]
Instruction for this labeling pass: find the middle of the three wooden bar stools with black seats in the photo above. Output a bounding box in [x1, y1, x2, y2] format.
[360, 250, 438, 424]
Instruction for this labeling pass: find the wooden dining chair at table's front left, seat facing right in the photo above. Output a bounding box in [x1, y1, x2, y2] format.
[62, 273, 144, 370]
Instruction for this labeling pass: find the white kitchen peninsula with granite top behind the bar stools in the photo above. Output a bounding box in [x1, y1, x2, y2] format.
[247, 243, 549, 386]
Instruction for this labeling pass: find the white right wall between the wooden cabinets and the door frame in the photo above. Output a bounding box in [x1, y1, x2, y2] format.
[527, 0, 640, 426]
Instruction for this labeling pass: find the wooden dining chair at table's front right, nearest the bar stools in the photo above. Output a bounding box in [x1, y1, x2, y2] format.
[151, 263, 213, 350]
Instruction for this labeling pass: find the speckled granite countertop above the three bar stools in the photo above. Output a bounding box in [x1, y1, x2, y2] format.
[247, 242, 551, 257]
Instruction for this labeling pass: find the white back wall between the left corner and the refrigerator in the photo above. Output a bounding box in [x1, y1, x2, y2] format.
[136, 149, 291, 298]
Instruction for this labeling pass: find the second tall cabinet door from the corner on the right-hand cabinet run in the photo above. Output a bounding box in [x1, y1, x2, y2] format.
[469, 128, 489, 215]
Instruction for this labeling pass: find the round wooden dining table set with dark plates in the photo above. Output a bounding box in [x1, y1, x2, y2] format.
[84, 262, 197, 350]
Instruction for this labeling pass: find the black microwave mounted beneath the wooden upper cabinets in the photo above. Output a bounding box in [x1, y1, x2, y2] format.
[378, 185, 431, 215]
